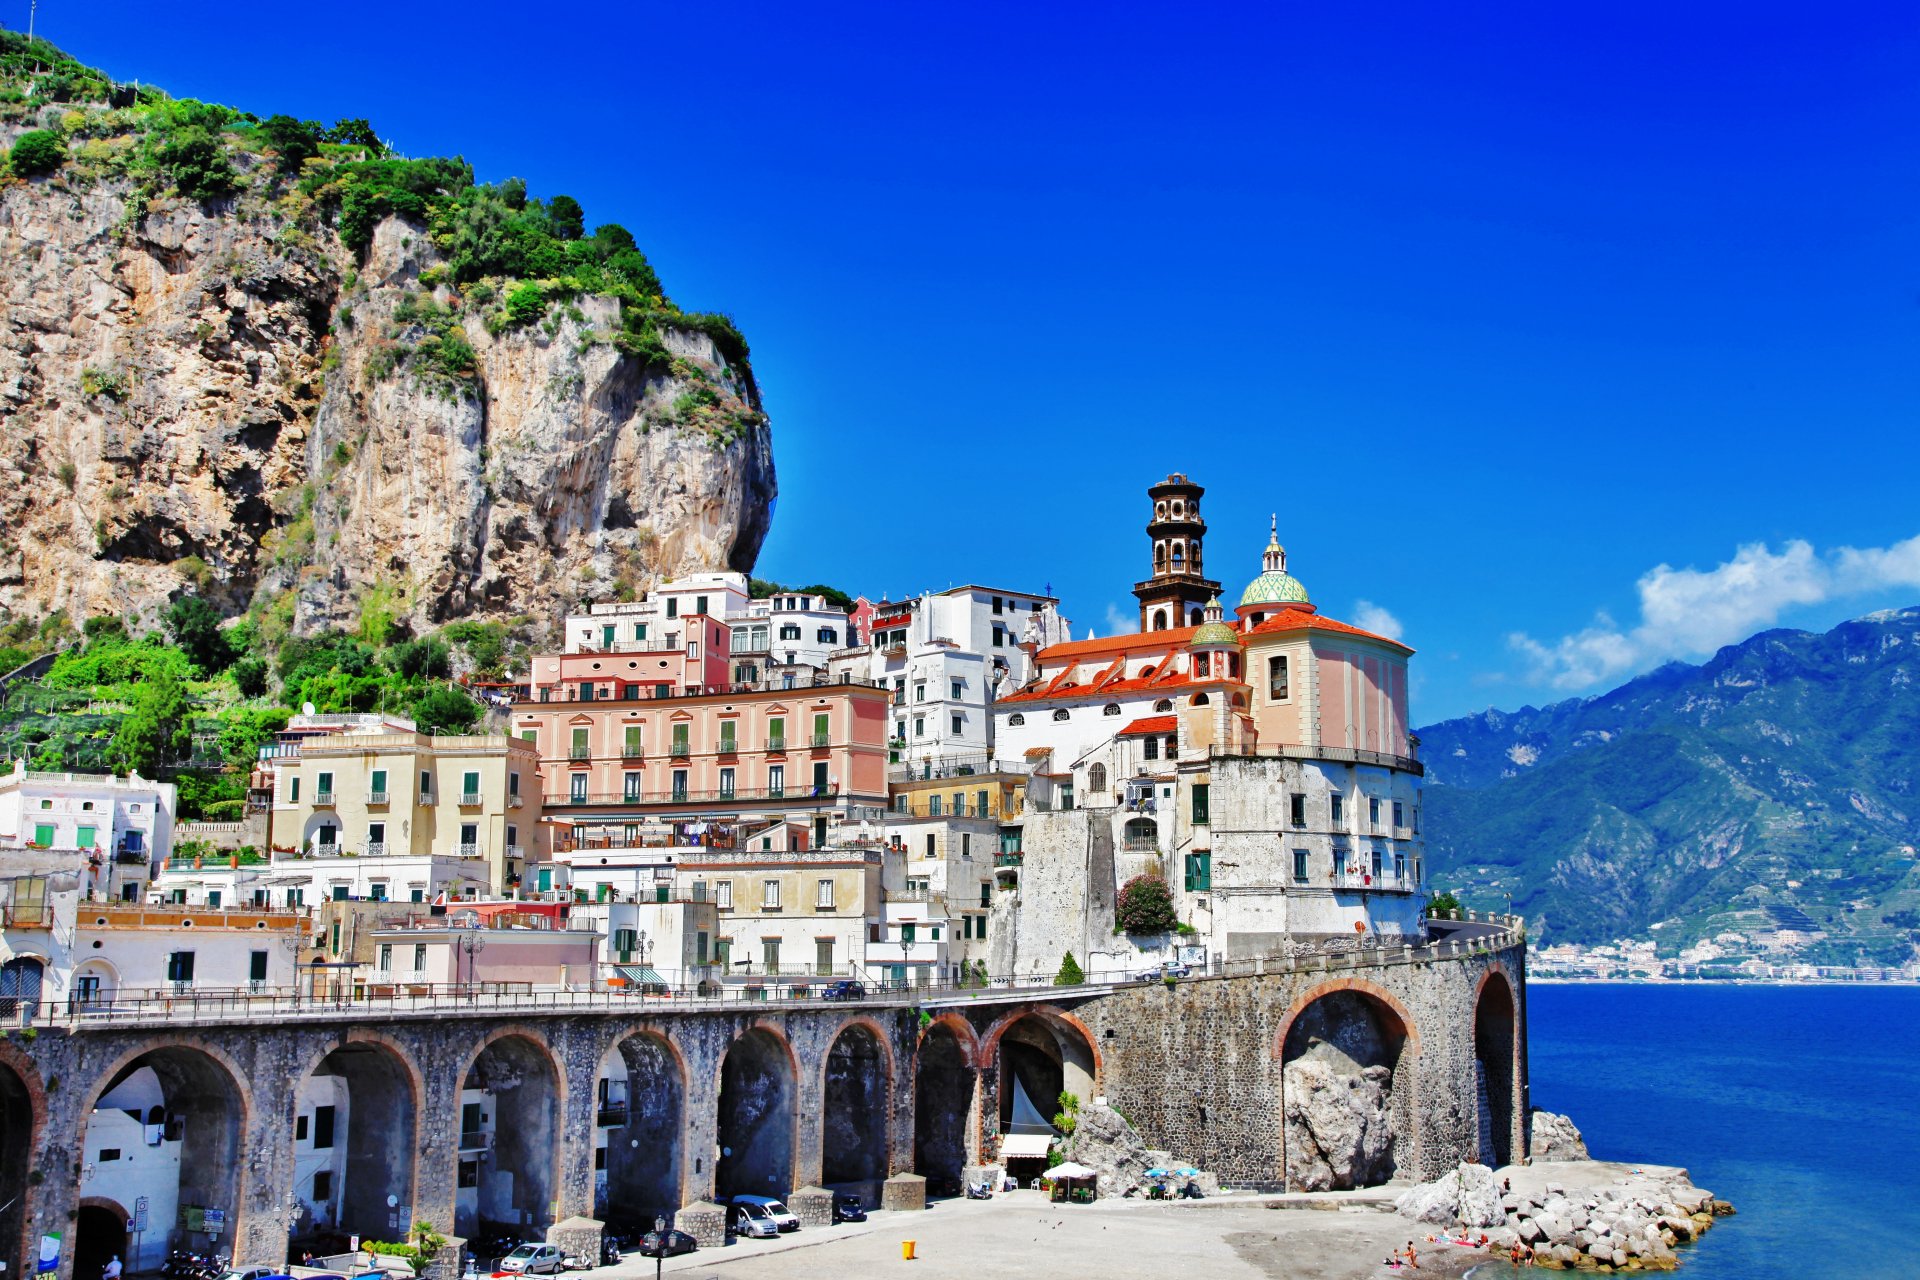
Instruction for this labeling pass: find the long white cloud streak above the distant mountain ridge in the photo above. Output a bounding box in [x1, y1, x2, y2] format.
[1507, 537, 1920, 689]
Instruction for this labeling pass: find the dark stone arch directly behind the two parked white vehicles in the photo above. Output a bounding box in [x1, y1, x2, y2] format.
[714, 1025, 799, 1197]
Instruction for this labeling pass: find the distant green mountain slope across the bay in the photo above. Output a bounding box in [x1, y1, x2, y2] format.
[1419, 608, 1920, 961]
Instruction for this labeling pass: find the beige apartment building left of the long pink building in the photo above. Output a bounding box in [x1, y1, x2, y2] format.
[267, 733, 540, 892]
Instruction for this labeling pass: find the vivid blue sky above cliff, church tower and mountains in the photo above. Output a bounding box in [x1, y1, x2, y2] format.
[30, 0, 1920, 722]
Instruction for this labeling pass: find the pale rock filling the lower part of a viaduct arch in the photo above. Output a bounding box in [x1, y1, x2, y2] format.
[1283, 1055, 1394, 1192]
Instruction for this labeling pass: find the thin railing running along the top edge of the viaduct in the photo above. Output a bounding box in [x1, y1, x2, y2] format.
[0, 912, 1526, 1031]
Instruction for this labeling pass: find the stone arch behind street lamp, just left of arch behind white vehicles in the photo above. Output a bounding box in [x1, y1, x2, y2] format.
[595, 1027, 687, 1234]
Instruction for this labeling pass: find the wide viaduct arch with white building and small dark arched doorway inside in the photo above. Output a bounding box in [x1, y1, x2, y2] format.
[73, 1046, 246, 1272]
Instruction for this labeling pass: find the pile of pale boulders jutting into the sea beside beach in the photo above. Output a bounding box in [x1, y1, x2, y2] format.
[1396, 1161, 1734, 1272]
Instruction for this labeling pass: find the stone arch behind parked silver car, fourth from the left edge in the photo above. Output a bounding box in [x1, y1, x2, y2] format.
[453, 1025, 566, 1240]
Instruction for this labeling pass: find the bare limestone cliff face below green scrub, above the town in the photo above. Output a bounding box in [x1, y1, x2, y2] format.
[0, 180, 776, 629]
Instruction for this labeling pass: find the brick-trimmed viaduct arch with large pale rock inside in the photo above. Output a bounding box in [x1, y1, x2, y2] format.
[1273, 979, 1421, 1190]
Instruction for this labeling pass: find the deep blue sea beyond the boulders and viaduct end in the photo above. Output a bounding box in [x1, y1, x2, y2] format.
[1526, 984, 1920, 1280]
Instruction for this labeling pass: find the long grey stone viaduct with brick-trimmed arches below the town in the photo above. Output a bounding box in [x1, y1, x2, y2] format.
[0, 927, 1528, 1280]
